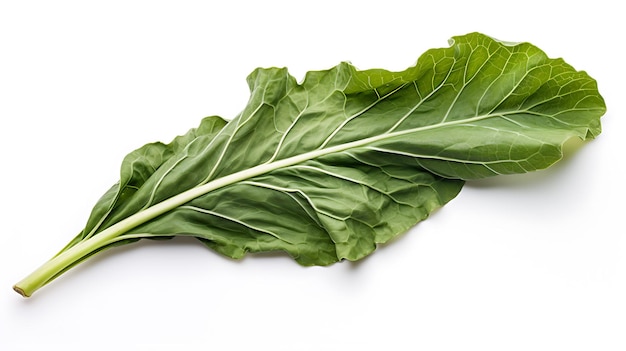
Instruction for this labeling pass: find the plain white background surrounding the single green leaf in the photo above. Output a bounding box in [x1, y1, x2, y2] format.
[0, 0, 626, 351]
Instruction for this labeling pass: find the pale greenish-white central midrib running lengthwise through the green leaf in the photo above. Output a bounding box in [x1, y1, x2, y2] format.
[15, 111, 508, 290]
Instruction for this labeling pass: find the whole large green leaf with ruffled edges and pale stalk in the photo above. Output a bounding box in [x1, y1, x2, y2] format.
[16, 33, 605, 296]
